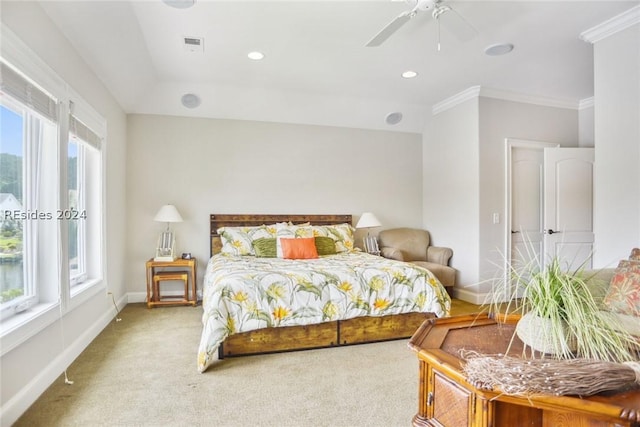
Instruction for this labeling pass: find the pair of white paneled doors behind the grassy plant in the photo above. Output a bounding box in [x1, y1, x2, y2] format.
[504, 139, 593, 297]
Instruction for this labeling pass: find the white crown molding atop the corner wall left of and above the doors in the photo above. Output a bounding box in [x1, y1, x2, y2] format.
[432, 86, 579, 116]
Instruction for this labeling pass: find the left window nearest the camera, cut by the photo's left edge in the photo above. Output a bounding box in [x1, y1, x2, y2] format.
[0, 64, 58, 319]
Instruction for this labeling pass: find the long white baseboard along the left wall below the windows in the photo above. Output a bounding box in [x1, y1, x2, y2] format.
[0, 295, 127, 427]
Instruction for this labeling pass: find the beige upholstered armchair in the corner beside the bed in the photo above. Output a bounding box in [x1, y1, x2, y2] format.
[378, 228, 456, 287]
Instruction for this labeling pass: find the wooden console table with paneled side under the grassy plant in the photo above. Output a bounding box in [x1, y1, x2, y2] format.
[409, 314, 640, 427]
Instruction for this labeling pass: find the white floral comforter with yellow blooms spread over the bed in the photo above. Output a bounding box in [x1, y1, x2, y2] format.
[198, 252, 451, 372]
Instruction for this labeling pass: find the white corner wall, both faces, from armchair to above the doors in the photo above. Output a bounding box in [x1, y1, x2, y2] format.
[423, 92, 578, 303]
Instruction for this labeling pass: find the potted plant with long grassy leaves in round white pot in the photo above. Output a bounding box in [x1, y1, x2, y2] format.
[490, 257, 638, 362]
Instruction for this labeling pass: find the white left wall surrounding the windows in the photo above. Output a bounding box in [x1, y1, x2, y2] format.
[0, 2, 127, 425]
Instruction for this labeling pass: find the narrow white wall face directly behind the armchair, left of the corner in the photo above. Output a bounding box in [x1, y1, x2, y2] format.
[423, 97, 479, 288]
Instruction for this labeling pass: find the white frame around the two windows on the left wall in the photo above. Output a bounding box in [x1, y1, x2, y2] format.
[0, 24, 107, 356]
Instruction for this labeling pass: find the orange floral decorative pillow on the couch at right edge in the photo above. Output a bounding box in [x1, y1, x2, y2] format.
[604, 260, 640, 316]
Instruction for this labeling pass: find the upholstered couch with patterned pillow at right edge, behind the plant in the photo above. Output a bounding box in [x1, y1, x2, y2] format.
[584, 262, 640, 337]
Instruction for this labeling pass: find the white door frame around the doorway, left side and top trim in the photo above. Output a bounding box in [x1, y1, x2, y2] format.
[502, 138, 560, 292]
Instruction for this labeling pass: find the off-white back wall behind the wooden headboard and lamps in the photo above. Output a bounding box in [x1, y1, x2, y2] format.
[127, 115, 422, 301]
